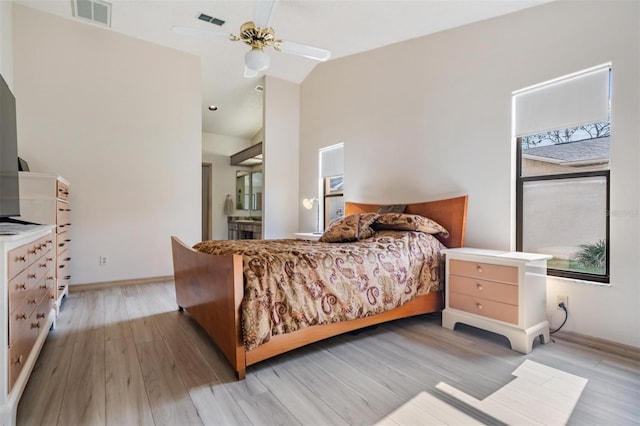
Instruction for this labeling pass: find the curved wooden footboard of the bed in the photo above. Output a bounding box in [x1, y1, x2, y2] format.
[171, 237, 246, 379]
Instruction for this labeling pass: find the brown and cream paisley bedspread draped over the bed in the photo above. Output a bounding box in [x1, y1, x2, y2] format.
[194, 230, 444, 350]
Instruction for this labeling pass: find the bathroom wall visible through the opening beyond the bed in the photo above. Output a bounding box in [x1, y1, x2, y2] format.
[202, 133, 259, 240]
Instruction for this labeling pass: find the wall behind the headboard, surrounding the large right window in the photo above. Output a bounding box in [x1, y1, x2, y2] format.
[299, 1, 640, 347]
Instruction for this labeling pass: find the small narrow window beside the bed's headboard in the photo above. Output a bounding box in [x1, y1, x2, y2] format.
[320, 143, 344, 229]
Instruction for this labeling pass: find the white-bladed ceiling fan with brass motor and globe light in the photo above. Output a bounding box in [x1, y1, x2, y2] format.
[172, 0, 331, 78]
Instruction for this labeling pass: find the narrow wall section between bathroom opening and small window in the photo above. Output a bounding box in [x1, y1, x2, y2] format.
[262, 76, 302, 239]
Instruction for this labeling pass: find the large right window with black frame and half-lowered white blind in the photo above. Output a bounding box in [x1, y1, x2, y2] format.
[513, 64, 611, 283]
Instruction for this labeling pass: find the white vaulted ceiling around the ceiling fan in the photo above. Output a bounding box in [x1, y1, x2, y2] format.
[15, 0, 550, 139]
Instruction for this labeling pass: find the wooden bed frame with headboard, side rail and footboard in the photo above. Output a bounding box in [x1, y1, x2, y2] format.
[171, 195, 468, 380]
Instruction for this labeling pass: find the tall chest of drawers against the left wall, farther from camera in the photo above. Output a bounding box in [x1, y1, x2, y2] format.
[20, 172, 71, 310]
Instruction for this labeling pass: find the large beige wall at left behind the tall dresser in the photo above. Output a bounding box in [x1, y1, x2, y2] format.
[13, 2, 202, 285]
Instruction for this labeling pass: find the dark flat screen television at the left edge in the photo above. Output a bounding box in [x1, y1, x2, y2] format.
[0, 71, 20, 221]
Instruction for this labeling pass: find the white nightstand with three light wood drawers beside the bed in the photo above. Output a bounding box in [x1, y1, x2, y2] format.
[442, 248, 551, 354]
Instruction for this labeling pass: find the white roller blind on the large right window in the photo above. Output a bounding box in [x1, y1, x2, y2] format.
[514, 64, 611, 136]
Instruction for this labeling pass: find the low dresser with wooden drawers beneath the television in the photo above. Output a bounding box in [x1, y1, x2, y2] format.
[0, 224, 56, 426]
